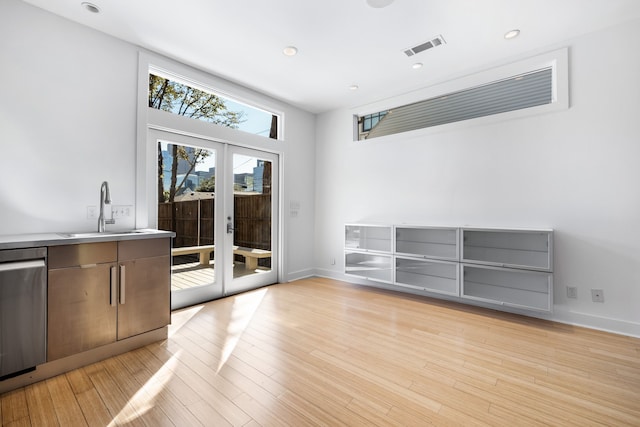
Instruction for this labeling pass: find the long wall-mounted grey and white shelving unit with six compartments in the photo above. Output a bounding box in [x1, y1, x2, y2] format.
[345, 224, 553, 312]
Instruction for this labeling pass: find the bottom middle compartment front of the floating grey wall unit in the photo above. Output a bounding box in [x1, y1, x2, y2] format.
[396, 257, 459, 296]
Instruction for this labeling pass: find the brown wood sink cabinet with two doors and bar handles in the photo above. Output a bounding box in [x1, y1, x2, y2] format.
[47, 238, 171, 361]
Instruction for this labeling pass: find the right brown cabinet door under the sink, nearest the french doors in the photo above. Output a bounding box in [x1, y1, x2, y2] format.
[118, 255, 171, 340]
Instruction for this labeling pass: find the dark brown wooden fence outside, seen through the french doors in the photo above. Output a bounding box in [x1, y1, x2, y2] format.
[158, 193, 271, 265]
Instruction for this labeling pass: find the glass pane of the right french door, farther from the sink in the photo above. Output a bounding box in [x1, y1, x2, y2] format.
[233, 154, 273, 278]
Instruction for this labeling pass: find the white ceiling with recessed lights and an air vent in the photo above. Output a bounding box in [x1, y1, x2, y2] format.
[24, 0, 640, 112]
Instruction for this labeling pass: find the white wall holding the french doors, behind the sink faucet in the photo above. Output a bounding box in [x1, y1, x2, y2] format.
[0, 0, 315, 280]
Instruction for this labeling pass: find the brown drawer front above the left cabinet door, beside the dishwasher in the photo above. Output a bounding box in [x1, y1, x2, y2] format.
[48, 242, 118, 269]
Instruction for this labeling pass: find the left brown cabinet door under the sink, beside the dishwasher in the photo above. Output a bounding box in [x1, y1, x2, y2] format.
[47, 264, 117, 361]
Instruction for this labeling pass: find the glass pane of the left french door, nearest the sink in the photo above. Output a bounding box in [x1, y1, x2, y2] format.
[158, 142, 216, 292]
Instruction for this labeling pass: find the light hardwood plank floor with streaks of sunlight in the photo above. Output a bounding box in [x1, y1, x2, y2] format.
[0, 279, 640, 426]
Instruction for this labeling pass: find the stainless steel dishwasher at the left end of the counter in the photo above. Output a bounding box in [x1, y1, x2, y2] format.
[0, 248, 47, 381]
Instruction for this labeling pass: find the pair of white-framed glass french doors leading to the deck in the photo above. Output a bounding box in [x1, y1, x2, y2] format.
[149, 129, 278, 309]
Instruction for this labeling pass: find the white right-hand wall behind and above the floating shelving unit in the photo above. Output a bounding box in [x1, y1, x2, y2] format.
[316, 18, 640, 336]
